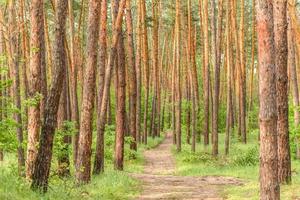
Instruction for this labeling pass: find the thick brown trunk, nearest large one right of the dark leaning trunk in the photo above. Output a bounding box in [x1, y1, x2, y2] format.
[75, 0, 101, 183]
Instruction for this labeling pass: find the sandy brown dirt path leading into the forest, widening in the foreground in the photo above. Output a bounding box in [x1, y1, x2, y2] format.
[132, 133, 242, 200]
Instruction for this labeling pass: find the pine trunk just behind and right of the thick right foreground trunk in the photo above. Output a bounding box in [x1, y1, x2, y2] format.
[273, 0, 291, 183]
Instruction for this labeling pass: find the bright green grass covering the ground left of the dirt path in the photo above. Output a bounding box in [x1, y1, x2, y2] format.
[0, 132, 163, 200]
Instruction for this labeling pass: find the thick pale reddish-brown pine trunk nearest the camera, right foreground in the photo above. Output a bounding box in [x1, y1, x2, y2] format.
[256, 0, 280, 200]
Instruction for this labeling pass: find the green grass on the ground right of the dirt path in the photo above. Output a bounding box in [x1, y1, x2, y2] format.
[173, 130, 300, 200]
